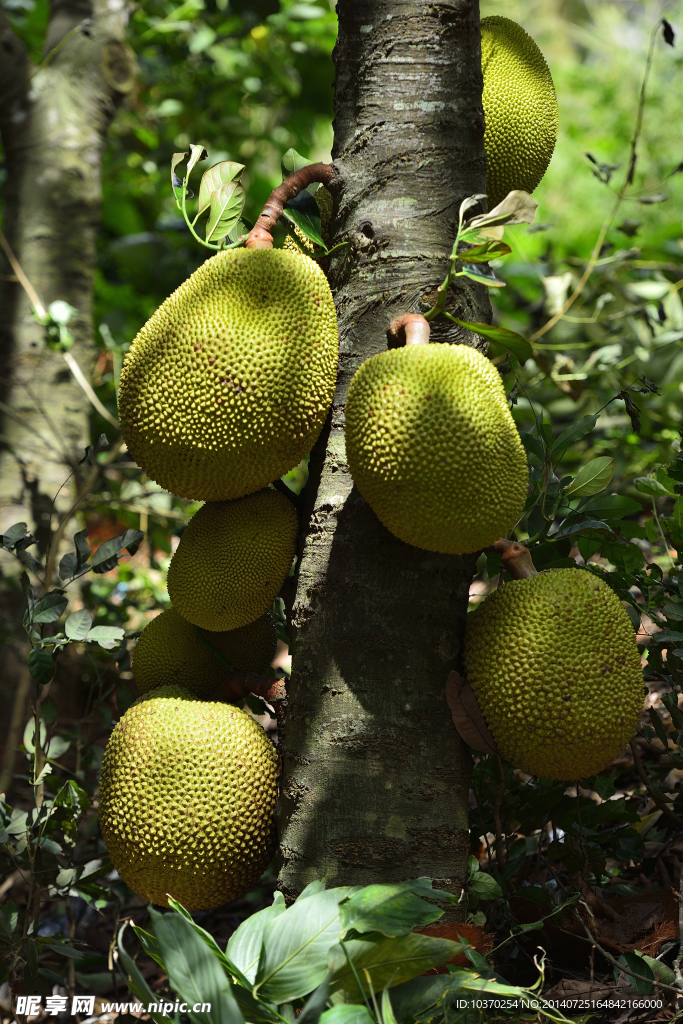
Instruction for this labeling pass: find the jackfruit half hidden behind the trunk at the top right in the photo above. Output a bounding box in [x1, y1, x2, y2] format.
[481, 16, 559, 210]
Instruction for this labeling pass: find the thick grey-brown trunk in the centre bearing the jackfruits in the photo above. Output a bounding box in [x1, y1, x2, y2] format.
[279, 0, 490, 913]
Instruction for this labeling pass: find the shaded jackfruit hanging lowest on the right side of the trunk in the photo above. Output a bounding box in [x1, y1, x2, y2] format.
[464, 567, 643, 780]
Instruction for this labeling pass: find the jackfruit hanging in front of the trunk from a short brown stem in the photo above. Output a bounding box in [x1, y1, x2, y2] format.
[346, 344, 528, 554]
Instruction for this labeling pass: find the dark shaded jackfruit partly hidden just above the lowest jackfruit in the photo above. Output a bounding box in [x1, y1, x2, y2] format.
[132, 608, 278, 699]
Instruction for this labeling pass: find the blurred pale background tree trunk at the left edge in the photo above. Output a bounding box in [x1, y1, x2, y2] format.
[0, 0, 135, 545]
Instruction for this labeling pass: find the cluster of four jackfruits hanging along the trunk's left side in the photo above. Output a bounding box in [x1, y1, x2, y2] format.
[105, 243, 337, 909]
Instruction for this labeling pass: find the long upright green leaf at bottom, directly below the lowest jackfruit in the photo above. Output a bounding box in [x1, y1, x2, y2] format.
[150, 907, 244, 1024]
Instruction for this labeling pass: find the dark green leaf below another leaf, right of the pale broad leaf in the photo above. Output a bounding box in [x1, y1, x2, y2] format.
[328, 932, 464, 1001]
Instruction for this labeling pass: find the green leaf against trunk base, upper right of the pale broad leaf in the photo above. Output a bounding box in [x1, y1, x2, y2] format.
[339, 879, 450, 936]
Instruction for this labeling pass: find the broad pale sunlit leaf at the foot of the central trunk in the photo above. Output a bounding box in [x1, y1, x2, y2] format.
[254, 886, 360, 1002]
